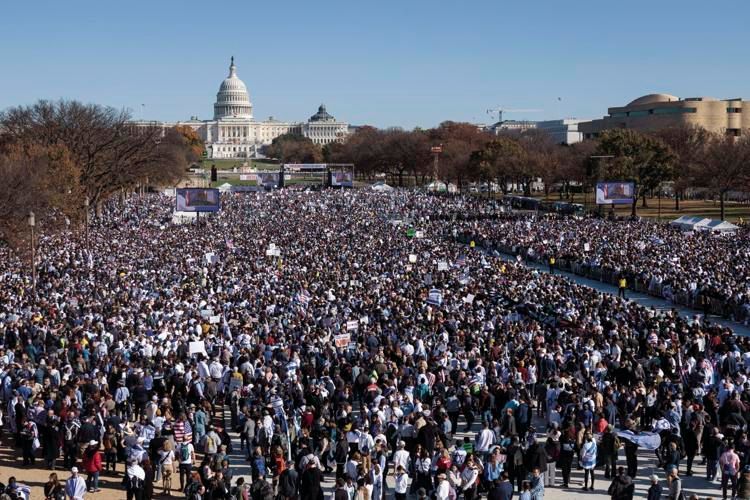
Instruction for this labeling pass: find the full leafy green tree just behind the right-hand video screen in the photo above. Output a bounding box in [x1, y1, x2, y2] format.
[597, 129, 675, 216]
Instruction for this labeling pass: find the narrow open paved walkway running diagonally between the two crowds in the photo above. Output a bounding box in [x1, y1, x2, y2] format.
[498, 253, 750, 337]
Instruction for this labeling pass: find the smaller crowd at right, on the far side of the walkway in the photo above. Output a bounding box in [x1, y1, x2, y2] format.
[450, 210, 750, 321]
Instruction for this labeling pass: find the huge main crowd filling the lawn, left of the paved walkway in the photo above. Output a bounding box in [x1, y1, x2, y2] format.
[0, 190, 750, 500]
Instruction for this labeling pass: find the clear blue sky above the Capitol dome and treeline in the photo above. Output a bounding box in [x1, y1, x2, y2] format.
[0, 0, 750, 128]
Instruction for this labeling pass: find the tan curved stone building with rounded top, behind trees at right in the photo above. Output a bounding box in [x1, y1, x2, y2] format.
[578, 94, 750, 139]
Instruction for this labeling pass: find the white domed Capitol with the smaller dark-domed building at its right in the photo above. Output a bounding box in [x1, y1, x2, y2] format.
[135, 57, 349, 158]
